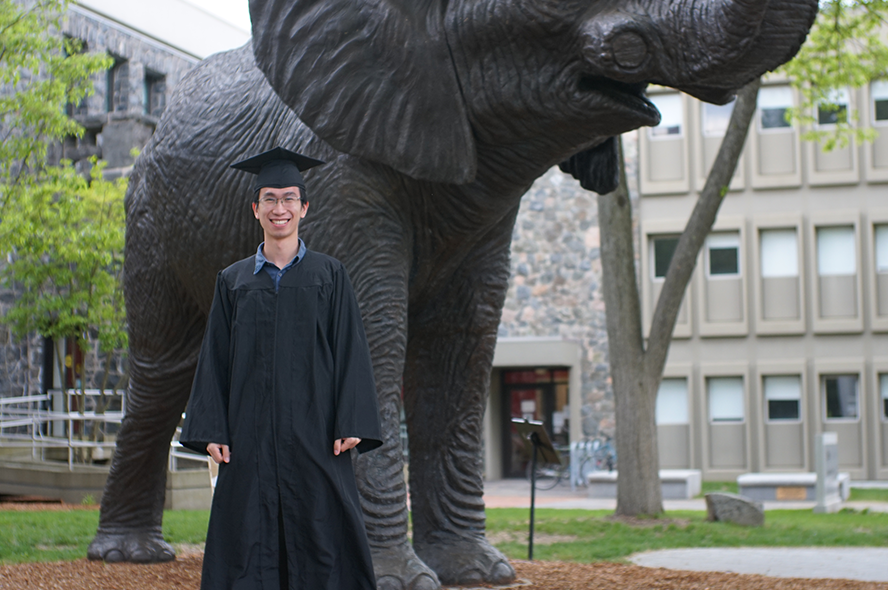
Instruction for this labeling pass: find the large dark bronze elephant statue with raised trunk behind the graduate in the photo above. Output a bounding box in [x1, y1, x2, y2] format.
[89, 0, 817, 590]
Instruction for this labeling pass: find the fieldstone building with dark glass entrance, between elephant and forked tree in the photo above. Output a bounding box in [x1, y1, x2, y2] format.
[484, 138, 637, 479]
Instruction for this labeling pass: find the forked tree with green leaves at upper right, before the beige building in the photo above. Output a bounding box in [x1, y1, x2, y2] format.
[598, 0, 888, 516]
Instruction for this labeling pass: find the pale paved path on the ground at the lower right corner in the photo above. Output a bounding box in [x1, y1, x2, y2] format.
[629, 547, 888, 582]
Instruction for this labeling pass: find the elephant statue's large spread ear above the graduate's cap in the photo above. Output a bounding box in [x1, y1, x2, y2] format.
[250, 0, 477, 184]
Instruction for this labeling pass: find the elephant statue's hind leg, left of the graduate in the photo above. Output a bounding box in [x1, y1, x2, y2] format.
[88, 208, 205, 563]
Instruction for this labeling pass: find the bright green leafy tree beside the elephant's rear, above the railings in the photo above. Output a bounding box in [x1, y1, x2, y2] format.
[0, 160, 127, 410]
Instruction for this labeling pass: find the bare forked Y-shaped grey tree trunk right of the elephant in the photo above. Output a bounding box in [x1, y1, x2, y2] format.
[598, 79, 761, 516]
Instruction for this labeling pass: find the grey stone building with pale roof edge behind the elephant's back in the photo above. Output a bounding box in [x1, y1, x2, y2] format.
[0, 0, 250, 396]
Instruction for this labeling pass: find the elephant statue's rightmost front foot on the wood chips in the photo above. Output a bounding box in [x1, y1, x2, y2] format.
[413, 534, 515, 586]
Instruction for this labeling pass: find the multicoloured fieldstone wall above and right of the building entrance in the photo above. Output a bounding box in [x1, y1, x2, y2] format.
[498, 133, 638, 436]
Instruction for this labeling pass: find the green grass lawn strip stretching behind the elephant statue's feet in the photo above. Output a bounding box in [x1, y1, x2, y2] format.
[0, 508, 888, 563]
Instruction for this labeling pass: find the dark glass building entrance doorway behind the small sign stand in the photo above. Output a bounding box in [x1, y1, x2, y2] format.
[501, 368, 570, 477]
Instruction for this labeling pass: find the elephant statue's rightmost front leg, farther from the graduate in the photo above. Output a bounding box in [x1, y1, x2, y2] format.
[404, 224, 515, 584]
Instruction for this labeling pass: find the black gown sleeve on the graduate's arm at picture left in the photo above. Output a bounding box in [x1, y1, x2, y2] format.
[179, 272, 232, 454]
